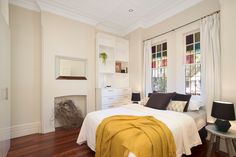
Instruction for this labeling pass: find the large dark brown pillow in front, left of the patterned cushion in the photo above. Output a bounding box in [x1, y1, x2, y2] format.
[146, 92, 175, 110]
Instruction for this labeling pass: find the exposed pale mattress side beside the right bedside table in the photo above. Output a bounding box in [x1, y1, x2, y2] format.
[184, 109, 207, 131]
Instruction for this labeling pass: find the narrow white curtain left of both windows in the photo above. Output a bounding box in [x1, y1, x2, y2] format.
[143, 40, 152, 97]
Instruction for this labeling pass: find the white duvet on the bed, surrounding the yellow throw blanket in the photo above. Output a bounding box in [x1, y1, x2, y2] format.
[77, 104, 201, 157]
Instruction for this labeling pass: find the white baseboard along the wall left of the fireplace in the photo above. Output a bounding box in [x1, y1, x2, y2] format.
[11, 122, 41, 138]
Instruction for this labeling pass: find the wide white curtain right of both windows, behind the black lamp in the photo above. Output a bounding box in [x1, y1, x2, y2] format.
[200, 13, 221, 122]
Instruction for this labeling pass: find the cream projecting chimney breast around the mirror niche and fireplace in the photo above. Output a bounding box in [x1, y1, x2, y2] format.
[41, 12, 95, 133]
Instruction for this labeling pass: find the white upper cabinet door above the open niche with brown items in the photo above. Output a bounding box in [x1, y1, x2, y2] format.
[115, 38, 129, 62]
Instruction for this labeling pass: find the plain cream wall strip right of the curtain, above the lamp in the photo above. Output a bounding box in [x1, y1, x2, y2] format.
[220, 0, 236, 130]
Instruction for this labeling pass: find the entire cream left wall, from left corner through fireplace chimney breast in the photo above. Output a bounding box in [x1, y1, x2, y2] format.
[10, 5, 125, 137]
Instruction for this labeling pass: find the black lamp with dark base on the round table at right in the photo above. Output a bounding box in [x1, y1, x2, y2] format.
[211, 101, 235, 132]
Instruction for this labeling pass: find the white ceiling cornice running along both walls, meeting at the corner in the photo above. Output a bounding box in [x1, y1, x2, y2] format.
[10, 0, 202, 36]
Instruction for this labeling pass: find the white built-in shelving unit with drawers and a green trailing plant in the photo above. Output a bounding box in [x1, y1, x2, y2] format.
[96, 33, 131, 110]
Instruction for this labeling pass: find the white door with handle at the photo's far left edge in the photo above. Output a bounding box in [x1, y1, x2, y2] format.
[0, 13, 10, 157]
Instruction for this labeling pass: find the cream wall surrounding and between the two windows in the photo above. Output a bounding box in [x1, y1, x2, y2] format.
[127, 0, 220, 95]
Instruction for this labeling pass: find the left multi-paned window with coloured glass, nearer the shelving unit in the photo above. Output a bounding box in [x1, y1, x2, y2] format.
[152, 42, 167, 92]
